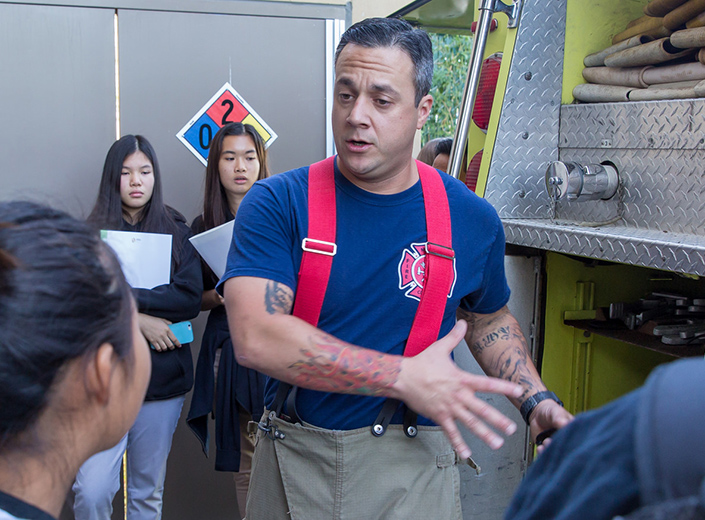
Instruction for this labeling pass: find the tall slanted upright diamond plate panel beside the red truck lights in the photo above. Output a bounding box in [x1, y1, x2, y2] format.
[485, 0, 566, 218]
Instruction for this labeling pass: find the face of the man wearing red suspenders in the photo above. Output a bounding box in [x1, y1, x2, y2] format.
[333, 44, 433, 191]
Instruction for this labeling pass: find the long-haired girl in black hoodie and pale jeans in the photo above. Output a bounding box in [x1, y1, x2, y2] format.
[73, 135, 203, 520]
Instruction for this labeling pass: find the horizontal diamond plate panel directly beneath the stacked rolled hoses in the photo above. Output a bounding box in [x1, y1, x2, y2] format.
[559, 99, 705, 150]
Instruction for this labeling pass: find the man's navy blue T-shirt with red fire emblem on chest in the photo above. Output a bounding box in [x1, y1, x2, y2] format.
[220, 161, 509, 430]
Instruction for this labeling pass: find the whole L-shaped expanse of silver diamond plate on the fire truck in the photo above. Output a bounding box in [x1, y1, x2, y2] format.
[485, 0, 705, 275]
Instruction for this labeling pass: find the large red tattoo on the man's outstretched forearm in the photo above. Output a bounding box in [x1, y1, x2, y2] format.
[289, 333, 401, 395]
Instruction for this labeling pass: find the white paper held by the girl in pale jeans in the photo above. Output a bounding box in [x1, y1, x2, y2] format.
[100, 229, 171, 289]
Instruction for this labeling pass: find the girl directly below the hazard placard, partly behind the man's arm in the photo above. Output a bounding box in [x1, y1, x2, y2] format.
[187, 123, 269, 518]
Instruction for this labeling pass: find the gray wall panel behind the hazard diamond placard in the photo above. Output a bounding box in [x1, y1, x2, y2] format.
[119, 10, 325, 218]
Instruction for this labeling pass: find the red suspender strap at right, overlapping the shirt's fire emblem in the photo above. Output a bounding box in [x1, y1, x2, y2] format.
[404, 161, 455, 357]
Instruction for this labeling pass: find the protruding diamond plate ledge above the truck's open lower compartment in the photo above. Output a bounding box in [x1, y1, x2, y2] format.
[504, 219, 705, 276]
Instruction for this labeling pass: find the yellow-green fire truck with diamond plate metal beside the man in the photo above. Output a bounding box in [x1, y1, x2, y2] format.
[394, 0, 705, 519]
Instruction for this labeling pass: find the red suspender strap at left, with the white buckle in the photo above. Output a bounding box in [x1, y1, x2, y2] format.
[294, 157, 336, 326]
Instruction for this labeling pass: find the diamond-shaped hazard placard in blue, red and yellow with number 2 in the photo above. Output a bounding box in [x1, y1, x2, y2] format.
[176, 83, 277, 166]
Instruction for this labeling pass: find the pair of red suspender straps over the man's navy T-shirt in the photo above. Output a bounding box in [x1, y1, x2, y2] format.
[294, 157, 455, 356]
